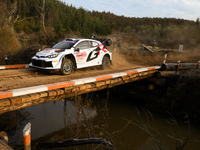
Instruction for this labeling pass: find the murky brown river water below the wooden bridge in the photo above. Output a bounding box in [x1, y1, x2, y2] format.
[1, 90, 200, 150]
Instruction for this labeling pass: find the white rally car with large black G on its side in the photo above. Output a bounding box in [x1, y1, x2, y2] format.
[29, 39, 112, 75]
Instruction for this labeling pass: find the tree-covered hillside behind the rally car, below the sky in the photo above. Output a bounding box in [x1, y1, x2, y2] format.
[0, 0, 200, 63]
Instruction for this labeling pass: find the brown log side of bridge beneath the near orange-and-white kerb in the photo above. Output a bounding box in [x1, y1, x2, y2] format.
[0, 70, 158, 114]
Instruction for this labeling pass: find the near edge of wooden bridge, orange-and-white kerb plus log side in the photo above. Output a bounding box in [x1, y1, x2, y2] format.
[0, 66, 160, 114]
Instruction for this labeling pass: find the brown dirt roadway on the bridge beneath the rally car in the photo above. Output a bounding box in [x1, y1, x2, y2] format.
[0, 54, 148, 91]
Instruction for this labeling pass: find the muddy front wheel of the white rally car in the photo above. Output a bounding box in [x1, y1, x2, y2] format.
[61, 59, 74, 75]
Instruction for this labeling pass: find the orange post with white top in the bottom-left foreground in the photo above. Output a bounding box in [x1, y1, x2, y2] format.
[23, 122, 31, 150]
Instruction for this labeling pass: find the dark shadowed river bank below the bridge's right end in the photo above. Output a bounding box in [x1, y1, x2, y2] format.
[111, 69, 200, 122]
